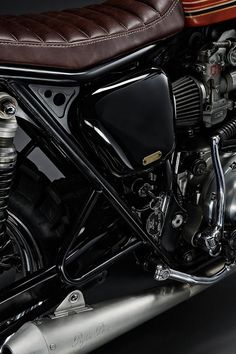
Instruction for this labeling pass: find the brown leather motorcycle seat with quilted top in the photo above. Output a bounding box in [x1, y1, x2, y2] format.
[0, 0, 184, 71]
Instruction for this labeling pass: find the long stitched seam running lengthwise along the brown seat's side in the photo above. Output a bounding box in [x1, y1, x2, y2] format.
[0, 0, 179, 48]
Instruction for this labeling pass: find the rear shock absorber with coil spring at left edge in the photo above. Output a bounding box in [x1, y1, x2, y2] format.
[0, 92, 18, 242]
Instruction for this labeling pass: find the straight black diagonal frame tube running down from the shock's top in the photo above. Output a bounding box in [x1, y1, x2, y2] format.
[5, 81, 169, 263]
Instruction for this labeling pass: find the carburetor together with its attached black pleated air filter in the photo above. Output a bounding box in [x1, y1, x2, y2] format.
[173, 30, 236, 128]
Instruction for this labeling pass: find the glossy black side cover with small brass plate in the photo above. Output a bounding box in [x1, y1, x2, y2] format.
[80, 69, 175, 174]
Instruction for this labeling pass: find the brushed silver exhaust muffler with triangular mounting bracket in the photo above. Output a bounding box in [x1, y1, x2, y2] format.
[2, 262, 234, 354]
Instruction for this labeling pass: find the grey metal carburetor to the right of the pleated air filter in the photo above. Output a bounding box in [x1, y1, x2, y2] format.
[195, 30, 236, 127]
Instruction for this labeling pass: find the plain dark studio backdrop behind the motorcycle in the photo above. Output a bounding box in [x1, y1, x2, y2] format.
[0, 0, 236, 354]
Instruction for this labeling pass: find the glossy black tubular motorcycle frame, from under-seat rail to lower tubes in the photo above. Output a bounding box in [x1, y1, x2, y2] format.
[0, 45, 169, 335]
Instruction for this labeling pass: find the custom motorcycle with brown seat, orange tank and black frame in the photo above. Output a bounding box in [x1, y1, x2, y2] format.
[0, 0, 236, 354]
